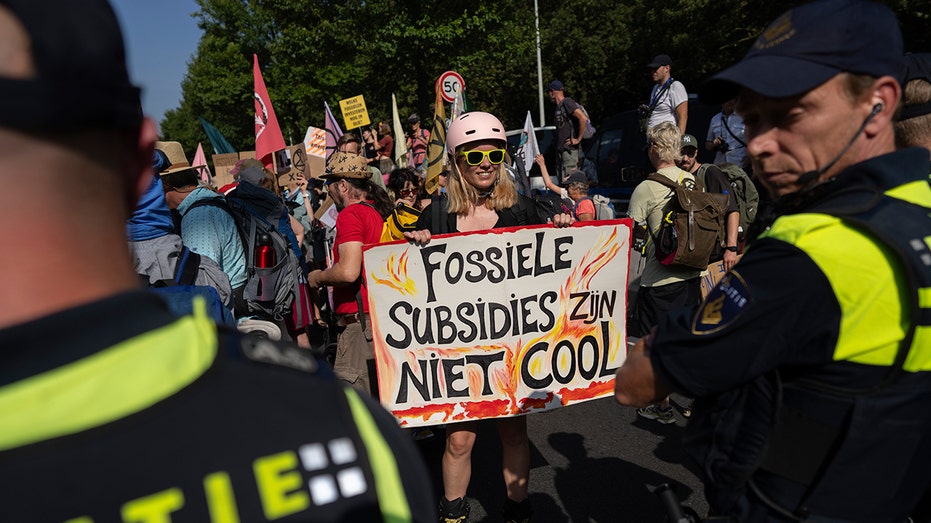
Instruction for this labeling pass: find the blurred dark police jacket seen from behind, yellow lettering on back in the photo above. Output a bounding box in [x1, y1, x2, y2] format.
[0, 292, 436, 523]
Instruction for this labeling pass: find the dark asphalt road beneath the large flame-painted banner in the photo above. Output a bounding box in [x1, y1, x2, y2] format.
[417, 397, 707, 523]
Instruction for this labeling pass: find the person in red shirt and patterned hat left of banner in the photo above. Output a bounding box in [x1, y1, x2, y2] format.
[307, 153, 394, 397]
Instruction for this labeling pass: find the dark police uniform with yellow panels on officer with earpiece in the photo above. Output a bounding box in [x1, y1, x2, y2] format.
[651, 149, 931, 522]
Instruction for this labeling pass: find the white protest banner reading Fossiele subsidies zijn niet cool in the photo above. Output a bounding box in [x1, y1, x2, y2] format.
[363, 219, 631, 427]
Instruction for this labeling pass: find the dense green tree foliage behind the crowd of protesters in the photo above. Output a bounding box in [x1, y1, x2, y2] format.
[161, 0, 931, 157]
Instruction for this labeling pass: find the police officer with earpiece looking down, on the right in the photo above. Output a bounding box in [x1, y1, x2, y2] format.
[615, 0, 931, 522]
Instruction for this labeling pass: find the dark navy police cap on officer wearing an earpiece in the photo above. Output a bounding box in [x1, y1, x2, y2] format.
[699, 0, 904, 104]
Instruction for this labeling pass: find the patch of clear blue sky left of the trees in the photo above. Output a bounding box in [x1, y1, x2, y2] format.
[110, 0, 201, 132]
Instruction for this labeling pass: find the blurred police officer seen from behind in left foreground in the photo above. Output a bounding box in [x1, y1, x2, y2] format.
[0, 0, 436, 522]
